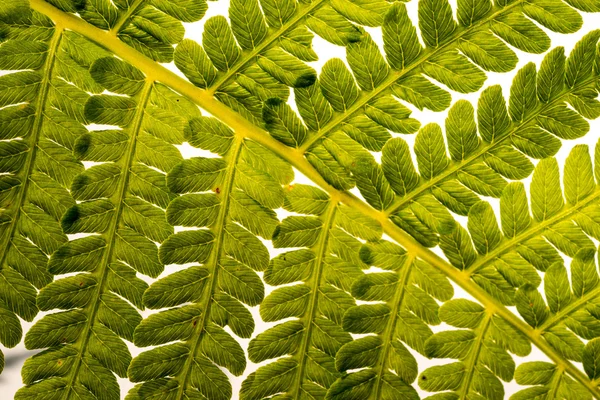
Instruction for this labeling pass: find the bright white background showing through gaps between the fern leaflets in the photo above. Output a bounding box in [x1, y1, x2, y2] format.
[0, 0, 600, 400]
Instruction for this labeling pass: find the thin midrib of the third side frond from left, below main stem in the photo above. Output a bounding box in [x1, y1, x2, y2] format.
[175, 136, 244, 399]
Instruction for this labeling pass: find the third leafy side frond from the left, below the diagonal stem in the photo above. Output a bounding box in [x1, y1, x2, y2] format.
[128, 117, 294, 399]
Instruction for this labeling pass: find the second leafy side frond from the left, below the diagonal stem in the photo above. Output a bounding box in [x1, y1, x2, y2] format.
[16, 56, 195, 400]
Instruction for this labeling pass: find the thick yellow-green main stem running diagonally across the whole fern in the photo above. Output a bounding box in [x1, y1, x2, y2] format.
[29, 0, 600, 399]
